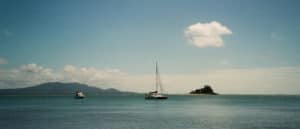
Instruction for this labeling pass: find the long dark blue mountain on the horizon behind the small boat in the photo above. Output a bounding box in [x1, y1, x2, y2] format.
[0, 82, 136, 95]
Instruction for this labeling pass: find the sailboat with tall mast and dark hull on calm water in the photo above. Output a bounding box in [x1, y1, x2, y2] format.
[145, 62, 168, 100]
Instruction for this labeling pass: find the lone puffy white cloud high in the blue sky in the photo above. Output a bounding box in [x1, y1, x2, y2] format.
[184, 21, 232, 48]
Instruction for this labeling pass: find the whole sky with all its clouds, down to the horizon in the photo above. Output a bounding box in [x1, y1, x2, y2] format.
[0, 0, 300, 94]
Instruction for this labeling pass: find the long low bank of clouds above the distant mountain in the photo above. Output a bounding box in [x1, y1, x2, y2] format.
[0, 64, 127, 88]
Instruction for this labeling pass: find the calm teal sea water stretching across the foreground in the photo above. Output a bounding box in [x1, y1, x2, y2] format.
[0, 95, 300, 129]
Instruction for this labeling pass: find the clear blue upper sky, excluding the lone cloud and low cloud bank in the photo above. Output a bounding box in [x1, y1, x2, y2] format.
[0, 0, 300, 93]
